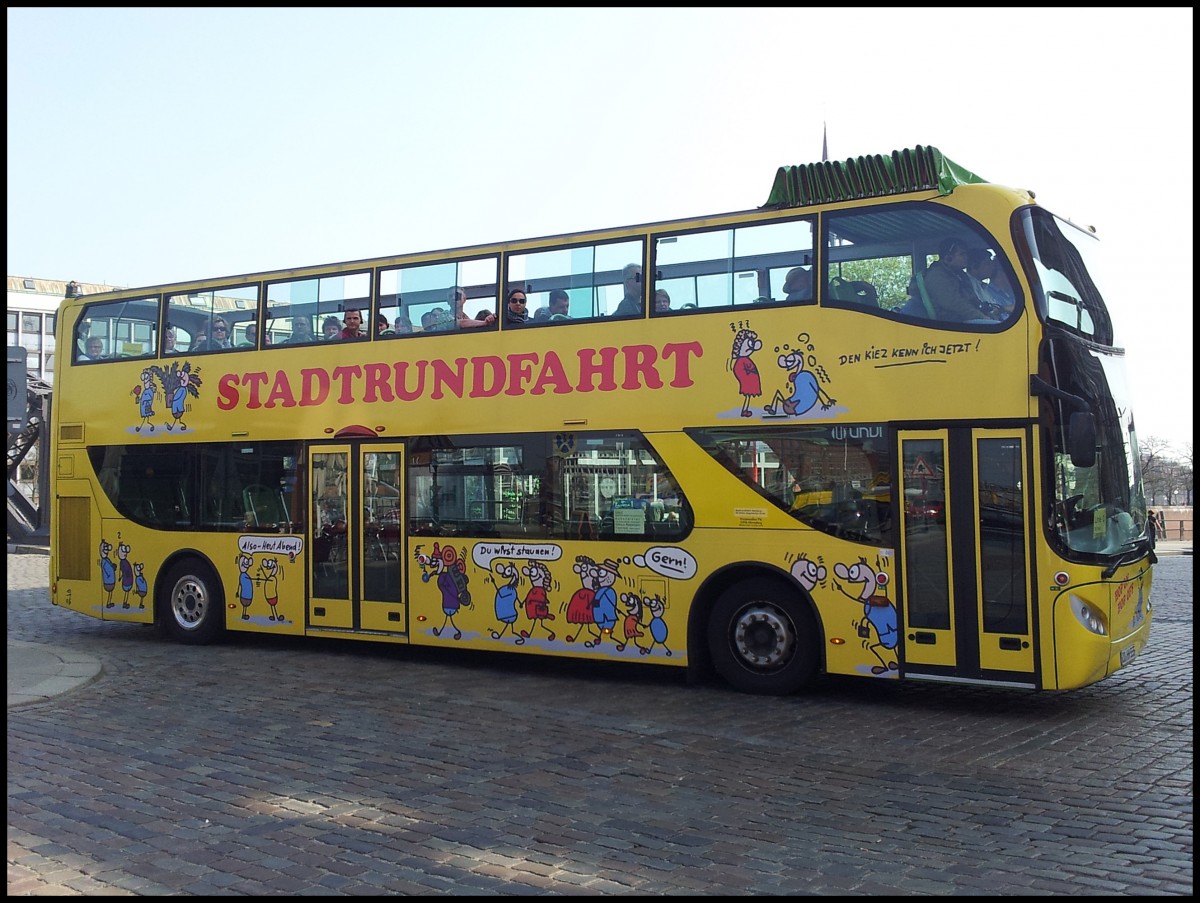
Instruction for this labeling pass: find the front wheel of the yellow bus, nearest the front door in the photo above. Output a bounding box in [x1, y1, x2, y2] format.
[708, 578, 818, 696]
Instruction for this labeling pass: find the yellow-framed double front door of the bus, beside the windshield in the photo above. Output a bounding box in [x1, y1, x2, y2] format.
[898, 427, 1037, 687]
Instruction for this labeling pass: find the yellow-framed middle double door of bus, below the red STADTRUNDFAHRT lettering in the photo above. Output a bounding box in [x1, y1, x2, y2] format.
[308, 442, 408, 634]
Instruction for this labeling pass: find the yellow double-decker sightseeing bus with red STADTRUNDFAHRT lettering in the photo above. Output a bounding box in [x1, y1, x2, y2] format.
[49, 146, 1154, 694]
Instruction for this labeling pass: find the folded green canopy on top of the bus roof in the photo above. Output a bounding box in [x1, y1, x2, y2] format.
[763, 144, 986, 210]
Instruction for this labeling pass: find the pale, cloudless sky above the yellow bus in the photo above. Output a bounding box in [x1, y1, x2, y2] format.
[7, 7, 1194, 452]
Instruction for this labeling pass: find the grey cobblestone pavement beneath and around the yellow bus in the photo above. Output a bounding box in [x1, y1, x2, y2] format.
[7, 555, 1193, 896]
